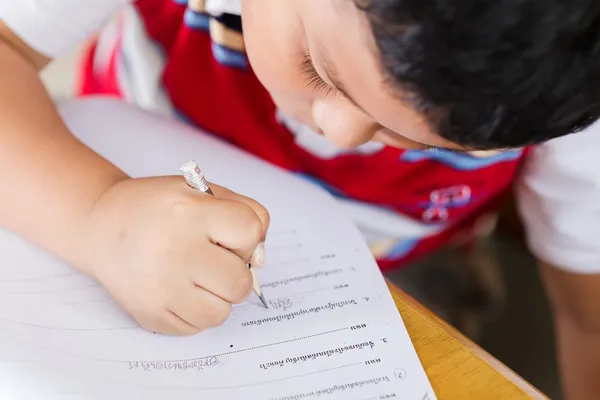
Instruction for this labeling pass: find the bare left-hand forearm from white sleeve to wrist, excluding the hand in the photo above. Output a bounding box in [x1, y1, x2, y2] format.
[0, 22, 124, 270]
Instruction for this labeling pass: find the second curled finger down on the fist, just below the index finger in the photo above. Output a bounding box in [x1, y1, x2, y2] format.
[187, 245, 253, 304]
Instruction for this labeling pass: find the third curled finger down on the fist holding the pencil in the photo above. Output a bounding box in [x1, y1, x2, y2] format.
[169, 281, 231, 330]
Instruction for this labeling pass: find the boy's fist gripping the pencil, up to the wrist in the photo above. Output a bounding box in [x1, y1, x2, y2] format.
[82, 177, 269, 335]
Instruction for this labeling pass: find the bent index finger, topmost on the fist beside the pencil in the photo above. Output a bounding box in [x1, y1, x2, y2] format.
[204, 199, 263, 263]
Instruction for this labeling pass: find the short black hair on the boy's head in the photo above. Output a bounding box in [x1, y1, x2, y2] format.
[364, 0, 600, 148]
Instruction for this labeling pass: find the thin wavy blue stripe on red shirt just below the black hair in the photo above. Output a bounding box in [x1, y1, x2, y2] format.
[400, 149, 523, 171]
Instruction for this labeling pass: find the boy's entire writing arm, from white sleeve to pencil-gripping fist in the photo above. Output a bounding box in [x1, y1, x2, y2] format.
[0, 0, 269, 335]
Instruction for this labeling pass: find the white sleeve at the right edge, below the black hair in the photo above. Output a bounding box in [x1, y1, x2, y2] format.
[517, 122, 600, 274]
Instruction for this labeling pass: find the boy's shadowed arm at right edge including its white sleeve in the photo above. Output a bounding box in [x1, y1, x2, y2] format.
[517, 123, 600, 400]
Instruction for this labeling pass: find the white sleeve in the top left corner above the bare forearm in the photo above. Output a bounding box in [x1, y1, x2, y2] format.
[0, 0, 132, 57]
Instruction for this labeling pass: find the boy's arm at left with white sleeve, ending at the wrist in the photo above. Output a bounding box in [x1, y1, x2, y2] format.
[0, 0, 129, 265]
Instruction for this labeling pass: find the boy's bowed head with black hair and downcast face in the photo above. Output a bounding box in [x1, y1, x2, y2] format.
[242, 0, 600, 150]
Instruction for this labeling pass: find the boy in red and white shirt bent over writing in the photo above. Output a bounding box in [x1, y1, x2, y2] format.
[0, 0, 600, 399]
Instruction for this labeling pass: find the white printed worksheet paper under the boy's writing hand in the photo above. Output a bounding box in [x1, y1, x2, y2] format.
[0, 99, 436, 400]
